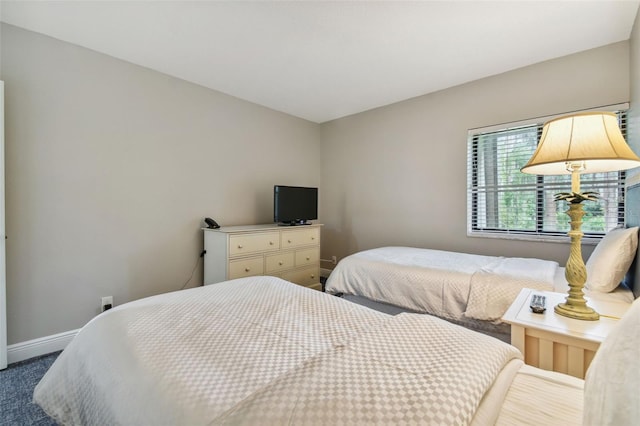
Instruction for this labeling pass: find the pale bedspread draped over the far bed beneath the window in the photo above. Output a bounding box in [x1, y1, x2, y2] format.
[326, 247, 558, 322]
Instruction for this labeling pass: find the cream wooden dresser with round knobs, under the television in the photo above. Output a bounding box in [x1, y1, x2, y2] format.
[203, 224, 322, 290]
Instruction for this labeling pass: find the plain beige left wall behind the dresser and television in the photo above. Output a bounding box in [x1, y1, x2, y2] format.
[1, 25, 320, 344]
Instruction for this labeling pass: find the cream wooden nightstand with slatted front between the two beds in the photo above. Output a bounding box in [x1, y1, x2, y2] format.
[502, 288, 631, 379]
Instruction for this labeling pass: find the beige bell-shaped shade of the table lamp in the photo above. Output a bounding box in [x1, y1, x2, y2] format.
[521, 112, 640, 175]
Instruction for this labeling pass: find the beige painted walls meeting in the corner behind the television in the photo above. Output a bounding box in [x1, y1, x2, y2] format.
[0, 21, 640, 344]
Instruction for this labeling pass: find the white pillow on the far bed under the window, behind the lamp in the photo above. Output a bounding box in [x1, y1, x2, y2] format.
[585, 226, 638, 293]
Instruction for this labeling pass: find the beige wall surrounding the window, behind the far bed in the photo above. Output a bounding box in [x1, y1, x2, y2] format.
[320, 42, 629, 266]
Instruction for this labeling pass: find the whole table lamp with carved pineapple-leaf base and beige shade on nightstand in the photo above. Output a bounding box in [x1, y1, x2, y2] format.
[521, 112, 640, 321]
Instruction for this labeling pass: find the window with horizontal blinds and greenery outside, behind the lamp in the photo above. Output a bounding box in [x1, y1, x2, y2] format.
[467, 111, 626, 240]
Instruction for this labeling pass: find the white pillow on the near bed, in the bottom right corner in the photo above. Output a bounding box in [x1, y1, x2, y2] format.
[583, 299, 640, 426]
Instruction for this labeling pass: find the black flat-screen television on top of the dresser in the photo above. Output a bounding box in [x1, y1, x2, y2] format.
[273, 185, 318, 226]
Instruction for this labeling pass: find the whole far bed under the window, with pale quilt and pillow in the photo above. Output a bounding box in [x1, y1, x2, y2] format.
[326, 227, 638, 342]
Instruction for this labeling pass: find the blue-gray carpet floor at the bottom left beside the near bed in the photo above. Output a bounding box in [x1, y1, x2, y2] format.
[0, 352, 60, 426]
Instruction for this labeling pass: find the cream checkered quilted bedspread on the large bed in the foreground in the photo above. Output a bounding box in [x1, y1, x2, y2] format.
[34, 277, 520, 425]
